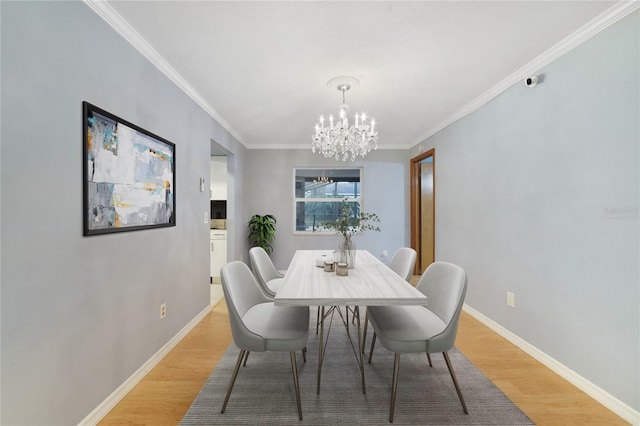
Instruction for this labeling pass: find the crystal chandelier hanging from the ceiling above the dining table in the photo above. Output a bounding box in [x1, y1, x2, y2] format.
[311, 77, 378, 161]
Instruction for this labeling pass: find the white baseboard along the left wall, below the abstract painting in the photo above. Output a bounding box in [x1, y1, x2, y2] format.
[79, 305, 213, 426]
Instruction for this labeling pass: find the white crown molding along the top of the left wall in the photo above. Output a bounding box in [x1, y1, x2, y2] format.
[83, 0, 246, 147]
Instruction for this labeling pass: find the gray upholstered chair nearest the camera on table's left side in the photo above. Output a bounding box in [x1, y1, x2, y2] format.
[220, 262, 309, 420]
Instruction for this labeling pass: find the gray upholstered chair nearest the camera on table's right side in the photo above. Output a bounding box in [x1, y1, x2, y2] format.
[368, 262, 468, 422]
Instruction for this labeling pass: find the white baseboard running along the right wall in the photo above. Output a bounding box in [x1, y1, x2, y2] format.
[463, 304, 640, 426]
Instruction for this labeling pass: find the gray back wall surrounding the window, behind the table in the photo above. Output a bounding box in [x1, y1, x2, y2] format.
[244, 149, 409, 269]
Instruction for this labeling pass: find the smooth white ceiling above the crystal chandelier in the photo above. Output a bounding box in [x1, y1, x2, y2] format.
[100, 0, 621, 148]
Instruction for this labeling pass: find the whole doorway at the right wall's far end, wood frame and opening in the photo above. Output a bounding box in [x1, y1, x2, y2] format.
[410, 149, 436, 274]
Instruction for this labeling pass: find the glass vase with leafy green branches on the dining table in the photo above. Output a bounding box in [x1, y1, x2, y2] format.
[324, 198, 380, 268]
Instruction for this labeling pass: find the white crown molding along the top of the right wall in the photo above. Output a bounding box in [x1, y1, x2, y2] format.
[410, 0, 640, 147]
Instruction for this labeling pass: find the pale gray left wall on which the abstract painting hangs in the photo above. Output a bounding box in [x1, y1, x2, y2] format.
[0, 2, 243, 425]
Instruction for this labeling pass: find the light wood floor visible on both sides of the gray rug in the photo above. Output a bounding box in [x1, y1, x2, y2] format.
[100, 301, 628, 426]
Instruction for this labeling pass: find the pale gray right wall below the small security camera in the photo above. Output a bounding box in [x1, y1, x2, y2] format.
[412, 12, 640, 410]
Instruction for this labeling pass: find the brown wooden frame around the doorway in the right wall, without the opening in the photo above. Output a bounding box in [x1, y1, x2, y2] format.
[409, 148, 436, 274]
